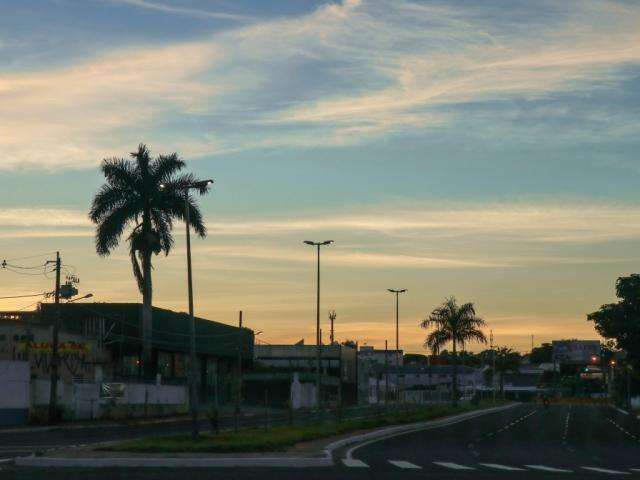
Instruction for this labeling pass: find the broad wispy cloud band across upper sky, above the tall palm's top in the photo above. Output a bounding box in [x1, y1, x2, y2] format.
[0, 0, 640, 169]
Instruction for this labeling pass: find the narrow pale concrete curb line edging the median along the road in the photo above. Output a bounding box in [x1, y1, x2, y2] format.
[15, 403, 518, 468]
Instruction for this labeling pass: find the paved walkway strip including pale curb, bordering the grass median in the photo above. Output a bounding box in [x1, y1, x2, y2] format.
[15, 403, 517, 468]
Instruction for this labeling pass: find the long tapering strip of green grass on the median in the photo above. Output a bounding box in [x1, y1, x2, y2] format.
[100, 402, 508, 453]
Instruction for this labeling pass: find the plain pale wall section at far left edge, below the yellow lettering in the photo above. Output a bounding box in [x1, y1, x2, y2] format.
[0, 360, 30, 426]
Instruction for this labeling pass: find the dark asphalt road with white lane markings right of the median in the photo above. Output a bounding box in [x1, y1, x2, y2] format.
[0, 404, 640, 480]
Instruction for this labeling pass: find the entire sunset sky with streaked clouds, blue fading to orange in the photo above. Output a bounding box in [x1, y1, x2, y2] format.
[0, 0, 640, 352]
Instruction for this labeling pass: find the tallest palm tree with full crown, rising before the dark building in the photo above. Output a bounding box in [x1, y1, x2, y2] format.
[89, 144, 208, 375]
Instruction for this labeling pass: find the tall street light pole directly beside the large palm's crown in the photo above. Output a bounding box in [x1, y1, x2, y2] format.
[159, 179, 213, 438]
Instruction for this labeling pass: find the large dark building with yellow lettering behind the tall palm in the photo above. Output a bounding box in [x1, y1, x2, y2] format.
[0, 303, 254, 418]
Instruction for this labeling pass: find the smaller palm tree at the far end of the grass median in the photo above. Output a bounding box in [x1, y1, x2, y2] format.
[420, 297, 487, 407]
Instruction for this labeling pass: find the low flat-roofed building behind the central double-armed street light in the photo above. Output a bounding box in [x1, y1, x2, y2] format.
[250, 344, 358, 407]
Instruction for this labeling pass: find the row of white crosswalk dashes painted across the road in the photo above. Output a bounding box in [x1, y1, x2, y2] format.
[342, 458, 640, 475]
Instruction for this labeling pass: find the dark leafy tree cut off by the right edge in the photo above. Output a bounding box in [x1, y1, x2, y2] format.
[587, 274, 640, 365]
